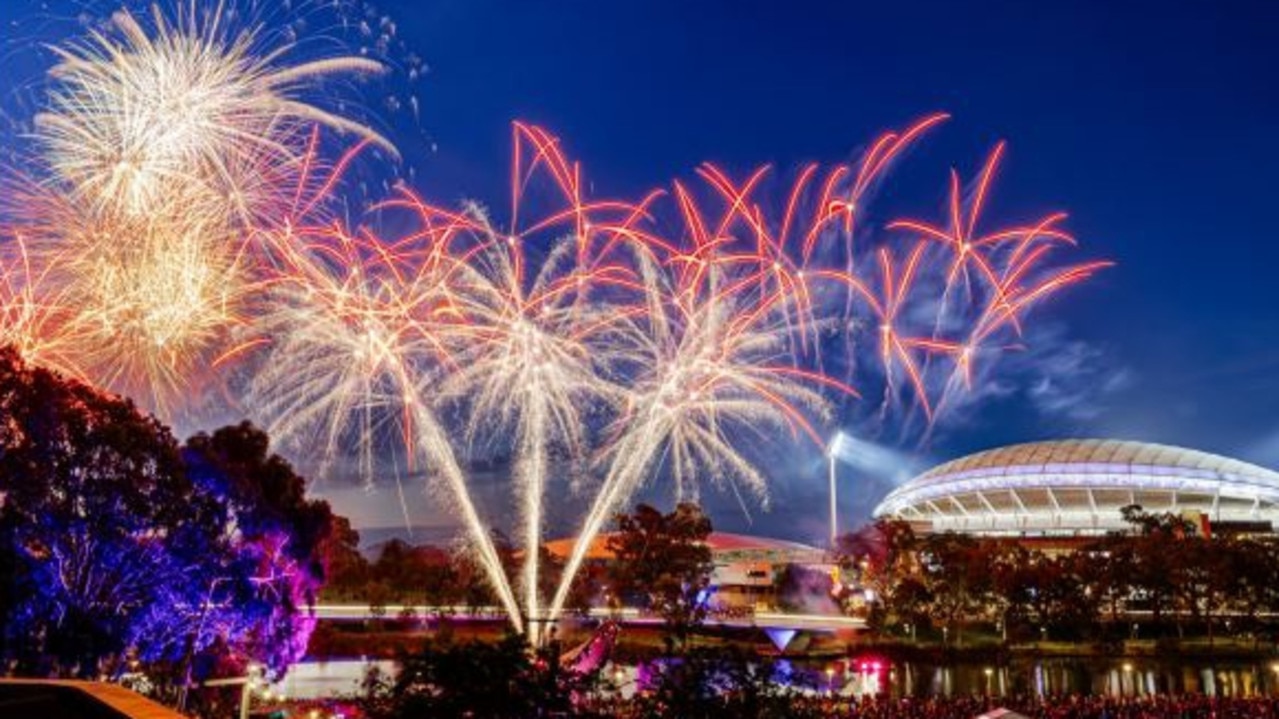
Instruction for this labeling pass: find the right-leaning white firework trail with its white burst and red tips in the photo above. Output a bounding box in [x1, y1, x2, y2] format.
[550, 166, 856, 617]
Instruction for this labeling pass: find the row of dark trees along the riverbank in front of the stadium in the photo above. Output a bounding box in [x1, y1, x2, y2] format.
[840, 505, 1279, 642]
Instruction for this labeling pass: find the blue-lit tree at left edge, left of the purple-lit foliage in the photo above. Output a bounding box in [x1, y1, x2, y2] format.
[0, 349, 216, 677]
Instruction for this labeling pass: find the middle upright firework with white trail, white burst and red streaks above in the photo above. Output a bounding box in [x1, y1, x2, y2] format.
[388, 124, 642, 642]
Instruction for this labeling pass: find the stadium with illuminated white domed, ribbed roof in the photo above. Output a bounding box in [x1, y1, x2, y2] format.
[874, 439, 1279, 537]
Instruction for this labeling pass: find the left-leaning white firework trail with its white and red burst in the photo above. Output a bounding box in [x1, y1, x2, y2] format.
[249, 220, 523, 631]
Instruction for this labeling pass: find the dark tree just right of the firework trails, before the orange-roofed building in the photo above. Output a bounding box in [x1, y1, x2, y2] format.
[608, 503, 715, 650]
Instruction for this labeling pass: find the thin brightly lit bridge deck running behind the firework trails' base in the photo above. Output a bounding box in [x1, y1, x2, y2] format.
[316, 604, 866, 632]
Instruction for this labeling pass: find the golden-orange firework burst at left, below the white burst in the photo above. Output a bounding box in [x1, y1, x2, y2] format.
[4, 175, 249, 416]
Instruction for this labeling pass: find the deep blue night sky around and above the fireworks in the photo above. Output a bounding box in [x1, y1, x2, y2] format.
[0, 0, 1279, 540]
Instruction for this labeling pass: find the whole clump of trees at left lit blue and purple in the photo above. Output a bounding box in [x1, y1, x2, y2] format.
[0, 349, 331, 679]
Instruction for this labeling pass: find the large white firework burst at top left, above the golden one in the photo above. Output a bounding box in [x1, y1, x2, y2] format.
[36, 5, 394, 217]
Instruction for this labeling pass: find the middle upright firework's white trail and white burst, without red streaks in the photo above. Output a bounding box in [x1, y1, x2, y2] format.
[441, 222, 616, 640]
